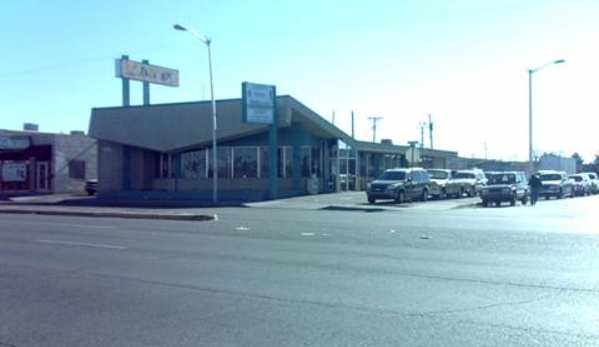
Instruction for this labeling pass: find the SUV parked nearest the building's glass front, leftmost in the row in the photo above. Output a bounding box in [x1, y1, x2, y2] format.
[366, 168, 431, 204]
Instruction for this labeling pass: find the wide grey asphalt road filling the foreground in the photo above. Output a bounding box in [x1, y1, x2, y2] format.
[0, 196, 599, 347]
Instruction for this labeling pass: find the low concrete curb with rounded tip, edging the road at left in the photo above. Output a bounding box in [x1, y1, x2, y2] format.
[0, 209, 218, 221]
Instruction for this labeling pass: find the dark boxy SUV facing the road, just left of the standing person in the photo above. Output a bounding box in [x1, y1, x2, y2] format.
[480, 171, 529, 207]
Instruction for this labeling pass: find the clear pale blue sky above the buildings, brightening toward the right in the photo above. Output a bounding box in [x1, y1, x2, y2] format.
[0, 0, 599, 160]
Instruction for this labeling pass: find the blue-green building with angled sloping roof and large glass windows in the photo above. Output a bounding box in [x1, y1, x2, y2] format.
[89, 96, 457, 201]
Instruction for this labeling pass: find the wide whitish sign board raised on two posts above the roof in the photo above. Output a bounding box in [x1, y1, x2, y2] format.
[116, 59, 179, 87]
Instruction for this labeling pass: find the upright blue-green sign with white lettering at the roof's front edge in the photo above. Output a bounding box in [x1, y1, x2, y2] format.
[242, 82, 277, 124]
